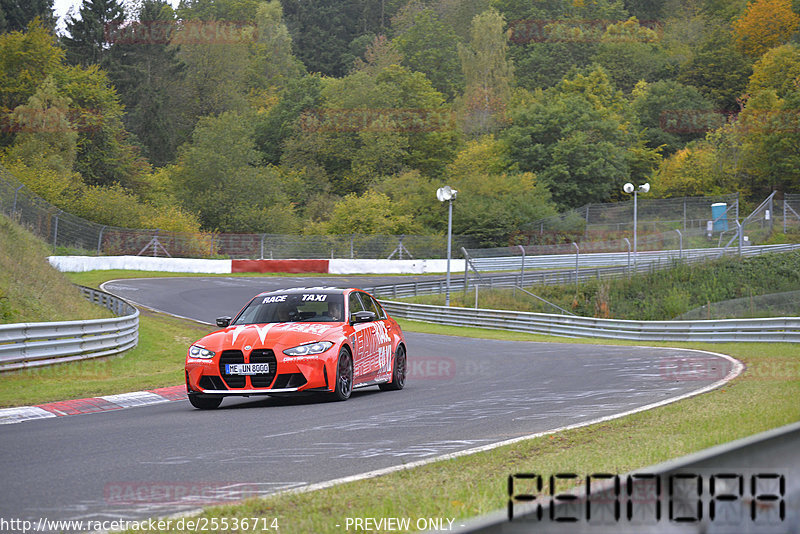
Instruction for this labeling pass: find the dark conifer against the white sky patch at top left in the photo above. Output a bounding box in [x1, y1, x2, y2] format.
[63, 0, 125, 66]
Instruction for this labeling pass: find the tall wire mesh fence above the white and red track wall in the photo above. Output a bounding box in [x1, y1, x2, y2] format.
[0, 167, 477, 259]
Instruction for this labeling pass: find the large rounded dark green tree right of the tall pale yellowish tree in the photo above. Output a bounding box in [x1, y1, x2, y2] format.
[502, 68, 658, 209]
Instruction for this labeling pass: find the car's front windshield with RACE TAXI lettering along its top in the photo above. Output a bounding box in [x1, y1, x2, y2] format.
[231, 291, 344, 325]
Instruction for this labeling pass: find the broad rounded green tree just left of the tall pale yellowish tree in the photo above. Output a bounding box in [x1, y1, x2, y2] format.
[282, 65, 457, 195]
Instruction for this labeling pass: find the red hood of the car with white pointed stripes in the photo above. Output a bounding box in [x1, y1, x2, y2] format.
[195, 323, 341, 351]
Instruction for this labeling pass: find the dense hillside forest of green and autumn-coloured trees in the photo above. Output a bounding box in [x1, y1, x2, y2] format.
[0, 0, 800, 245]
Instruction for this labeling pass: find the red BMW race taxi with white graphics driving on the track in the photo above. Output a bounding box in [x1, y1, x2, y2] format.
[186, 287, 406, 409]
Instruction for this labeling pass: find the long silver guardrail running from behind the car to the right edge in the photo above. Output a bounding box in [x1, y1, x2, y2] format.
[381, 300, 800, 343]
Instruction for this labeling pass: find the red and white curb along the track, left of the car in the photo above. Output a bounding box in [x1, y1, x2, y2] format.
[0, 385, 186, 425]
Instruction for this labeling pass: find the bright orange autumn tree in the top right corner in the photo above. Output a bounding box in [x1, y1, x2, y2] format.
[733, 0, 800, 57]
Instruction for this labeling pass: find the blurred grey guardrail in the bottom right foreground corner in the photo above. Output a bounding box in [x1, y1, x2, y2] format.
[454, 423, 800, 534]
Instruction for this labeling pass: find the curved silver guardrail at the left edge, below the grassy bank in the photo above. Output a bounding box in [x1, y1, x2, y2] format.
[0, 286, 139, 372]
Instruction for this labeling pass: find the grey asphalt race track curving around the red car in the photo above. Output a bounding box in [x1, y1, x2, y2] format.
[0, 277, 731, 520]
